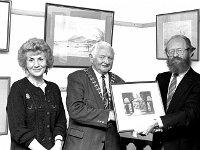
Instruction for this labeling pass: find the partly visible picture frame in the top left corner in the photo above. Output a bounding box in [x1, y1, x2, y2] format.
[0, 0, 11, 53]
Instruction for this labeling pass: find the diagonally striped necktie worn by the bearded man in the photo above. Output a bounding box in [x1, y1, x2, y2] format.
[166, 74, 178, 110]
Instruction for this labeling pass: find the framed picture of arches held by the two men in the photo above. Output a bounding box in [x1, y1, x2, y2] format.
[112, 81, 165, 133]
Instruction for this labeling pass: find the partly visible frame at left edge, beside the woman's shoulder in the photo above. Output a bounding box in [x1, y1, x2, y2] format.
[0, 77, 10, 135]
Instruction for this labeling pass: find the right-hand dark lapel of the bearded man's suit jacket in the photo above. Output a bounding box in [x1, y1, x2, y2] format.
[167, 69, 193, 112]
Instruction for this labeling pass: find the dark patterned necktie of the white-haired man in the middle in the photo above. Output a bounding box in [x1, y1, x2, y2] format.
[101, 75, 110, 109]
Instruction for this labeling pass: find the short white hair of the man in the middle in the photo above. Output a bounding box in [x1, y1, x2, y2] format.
[89, 41, 115, 57]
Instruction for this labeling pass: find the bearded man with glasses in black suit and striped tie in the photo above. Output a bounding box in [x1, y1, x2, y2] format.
[149, 35, 200, 150]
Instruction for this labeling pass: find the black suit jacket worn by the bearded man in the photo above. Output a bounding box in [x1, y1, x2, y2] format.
[152, 68, 200, 150]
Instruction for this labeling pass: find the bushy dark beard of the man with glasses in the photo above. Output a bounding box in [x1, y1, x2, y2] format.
[167, 55, 191, 74]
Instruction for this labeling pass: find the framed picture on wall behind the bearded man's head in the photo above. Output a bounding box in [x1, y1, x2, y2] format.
[156, 9, 199, 61]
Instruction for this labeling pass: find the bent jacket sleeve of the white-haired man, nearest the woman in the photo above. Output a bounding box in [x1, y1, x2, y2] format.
[66, 74, 109, 127]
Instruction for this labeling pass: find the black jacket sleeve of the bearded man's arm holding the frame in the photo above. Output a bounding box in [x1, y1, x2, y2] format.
[161, 80, 200, 129]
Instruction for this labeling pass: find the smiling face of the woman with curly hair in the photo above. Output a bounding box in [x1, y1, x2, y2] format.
[26, 51, 47, 78]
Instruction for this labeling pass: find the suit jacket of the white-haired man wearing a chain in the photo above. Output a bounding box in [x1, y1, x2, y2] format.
[64, 67, 124, 150]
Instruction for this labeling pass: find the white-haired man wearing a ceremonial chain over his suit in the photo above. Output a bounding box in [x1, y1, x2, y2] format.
[64, 41, 124, 150]
